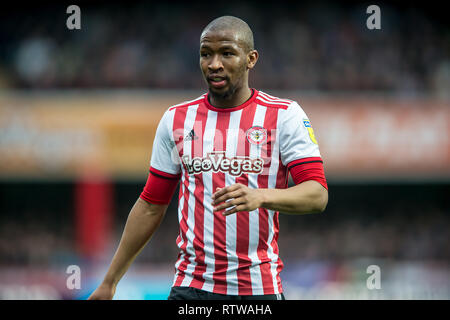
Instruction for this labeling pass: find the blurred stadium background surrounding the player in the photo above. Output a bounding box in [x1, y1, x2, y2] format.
[0, 1, 450, 299]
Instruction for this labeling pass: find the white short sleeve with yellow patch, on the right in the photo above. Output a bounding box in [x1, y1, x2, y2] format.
[278, 101, 320, 166]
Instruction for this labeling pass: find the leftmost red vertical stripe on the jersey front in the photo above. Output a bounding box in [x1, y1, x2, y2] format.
[173, 108, 190, 286]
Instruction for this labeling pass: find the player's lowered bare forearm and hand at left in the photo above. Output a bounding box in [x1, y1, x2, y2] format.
[89, 198, 168, 300]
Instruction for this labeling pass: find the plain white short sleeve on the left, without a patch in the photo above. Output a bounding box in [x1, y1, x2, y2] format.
[150, 110, 181, 174]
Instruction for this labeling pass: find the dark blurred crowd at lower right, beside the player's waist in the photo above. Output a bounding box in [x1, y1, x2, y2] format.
[279, 208, 450, 263]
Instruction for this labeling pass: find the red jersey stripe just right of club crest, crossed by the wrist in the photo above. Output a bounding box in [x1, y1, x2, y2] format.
[257, 108, 278, 294]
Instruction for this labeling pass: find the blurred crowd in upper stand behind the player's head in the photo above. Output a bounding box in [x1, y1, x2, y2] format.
[0, 2, 450, 97]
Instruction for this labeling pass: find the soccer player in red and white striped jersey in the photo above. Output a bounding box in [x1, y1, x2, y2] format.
[89, 16, 328, 300]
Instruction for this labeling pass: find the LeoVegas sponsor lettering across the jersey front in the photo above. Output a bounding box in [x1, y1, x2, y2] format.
[181, 151, 264, 176]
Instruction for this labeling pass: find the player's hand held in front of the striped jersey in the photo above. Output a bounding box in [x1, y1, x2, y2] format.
[212, 183, 263, 216]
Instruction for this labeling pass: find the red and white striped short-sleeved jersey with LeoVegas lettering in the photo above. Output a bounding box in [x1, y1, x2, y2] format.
[151, 89, 320, 295]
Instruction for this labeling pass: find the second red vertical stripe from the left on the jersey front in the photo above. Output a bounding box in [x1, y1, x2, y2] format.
[190, 107, 208, 288]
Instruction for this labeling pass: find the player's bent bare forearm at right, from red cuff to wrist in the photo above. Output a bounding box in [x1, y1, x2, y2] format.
[260, 181, 328, 214]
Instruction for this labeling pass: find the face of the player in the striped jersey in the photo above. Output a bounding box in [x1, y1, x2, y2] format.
[200, 30, 253, 99]
